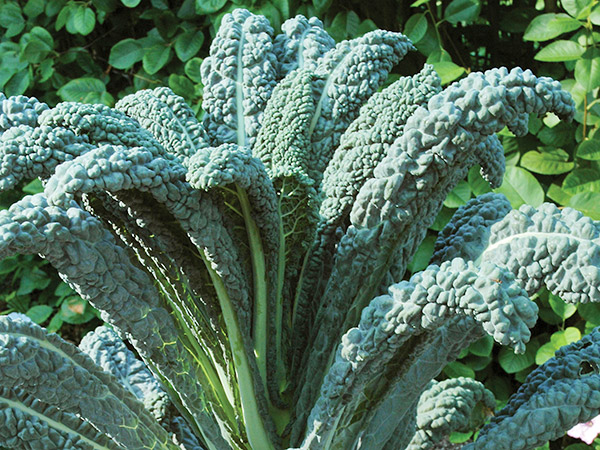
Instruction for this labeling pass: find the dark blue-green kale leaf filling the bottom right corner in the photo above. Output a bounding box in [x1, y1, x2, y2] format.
[465, 328, 600, 450]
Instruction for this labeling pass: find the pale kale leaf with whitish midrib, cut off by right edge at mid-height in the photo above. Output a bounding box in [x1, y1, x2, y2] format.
[479, 203, 600, 303]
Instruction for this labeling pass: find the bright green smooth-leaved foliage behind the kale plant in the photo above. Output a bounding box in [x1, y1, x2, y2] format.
[0, 0, 600, 448]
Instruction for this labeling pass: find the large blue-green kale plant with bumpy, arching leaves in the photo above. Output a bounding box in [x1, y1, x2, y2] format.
[0, 10, 600, 450]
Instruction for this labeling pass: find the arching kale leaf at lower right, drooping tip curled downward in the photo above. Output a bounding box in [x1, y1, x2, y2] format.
[303, 258, 538, 449]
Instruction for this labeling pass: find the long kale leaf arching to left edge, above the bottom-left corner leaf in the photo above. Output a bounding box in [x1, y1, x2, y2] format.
[0, 194, 232, 448]
